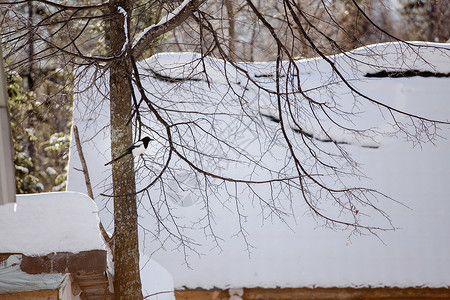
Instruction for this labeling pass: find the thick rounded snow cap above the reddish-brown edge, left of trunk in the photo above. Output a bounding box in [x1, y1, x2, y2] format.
[0, 192, 105, 256]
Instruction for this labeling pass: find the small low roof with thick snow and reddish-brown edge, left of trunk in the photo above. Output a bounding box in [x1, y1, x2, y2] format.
[0, 192, 106, 294]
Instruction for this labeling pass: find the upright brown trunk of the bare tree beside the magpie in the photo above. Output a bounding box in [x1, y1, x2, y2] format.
[110, 0, 142, 300]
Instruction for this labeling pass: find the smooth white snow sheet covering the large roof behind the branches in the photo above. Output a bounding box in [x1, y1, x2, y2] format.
[68, 44, 450, 289]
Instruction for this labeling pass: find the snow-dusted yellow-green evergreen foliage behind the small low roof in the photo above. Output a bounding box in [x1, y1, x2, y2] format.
[8, 74, 72, 194]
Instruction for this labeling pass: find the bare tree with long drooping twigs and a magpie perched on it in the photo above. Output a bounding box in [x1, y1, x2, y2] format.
[0, 0, 448, 299]
